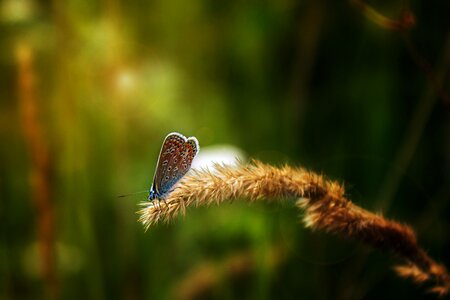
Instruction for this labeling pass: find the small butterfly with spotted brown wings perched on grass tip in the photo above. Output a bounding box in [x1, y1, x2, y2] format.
[148, 132, 200, 201]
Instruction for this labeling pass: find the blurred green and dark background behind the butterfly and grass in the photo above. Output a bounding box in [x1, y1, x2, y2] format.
[0, 0, 450, 299]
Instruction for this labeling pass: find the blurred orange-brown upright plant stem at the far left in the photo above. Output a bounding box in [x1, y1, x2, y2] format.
[14, 43, 58, 299]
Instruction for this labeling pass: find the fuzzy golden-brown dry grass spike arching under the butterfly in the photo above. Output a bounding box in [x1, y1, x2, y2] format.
[139, 161, 450, 296]
